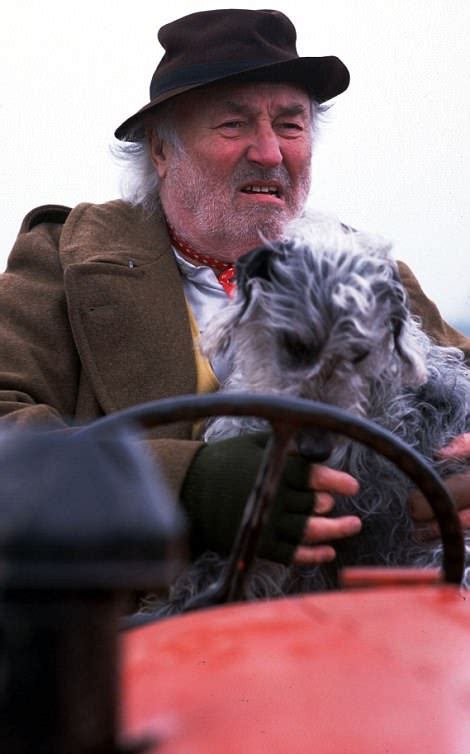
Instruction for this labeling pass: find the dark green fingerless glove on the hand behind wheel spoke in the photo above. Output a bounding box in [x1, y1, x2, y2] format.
[181, 433, 314, 565]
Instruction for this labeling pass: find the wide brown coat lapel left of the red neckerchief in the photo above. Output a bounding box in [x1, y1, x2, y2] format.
[60, 201, 196, 413]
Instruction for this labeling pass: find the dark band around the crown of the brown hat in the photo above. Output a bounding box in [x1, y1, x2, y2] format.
[150, 57, 299, 100]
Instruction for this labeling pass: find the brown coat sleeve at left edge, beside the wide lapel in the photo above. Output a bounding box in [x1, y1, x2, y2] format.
[0, 211, 80, 427]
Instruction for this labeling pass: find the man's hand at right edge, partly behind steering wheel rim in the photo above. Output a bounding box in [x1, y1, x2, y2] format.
[408, 433, 470, 541]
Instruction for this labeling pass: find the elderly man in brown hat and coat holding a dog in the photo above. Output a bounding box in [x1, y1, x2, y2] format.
[0, 10, 470, 563]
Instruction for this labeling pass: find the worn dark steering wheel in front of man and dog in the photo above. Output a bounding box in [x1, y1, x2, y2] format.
[86, 392, 465, 609]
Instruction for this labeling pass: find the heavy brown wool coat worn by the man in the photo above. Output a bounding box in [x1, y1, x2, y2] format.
[0, 201, 470, 489]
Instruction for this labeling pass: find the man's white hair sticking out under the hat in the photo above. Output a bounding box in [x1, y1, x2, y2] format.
[110, 97, 331, 215]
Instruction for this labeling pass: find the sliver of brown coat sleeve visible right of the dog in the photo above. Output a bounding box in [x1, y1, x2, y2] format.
[398, 262, 470, 361]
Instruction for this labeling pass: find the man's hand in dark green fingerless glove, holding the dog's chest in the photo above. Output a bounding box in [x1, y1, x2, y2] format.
[181, 433, 361, 565]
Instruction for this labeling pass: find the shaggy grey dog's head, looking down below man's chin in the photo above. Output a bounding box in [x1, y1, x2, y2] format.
[202, 229, 426, 414]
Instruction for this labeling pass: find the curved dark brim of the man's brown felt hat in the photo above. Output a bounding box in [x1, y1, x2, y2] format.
[114, 55, 349, 141]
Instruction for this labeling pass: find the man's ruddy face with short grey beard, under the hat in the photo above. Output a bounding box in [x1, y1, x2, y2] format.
[151, 83, 312, 260]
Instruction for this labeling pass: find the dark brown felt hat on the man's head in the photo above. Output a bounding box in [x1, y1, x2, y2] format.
[115, 9, 349, 141]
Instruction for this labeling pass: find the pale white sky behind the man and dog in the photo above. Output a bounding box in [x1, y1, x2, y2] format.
[0, 0, 470, 332]
